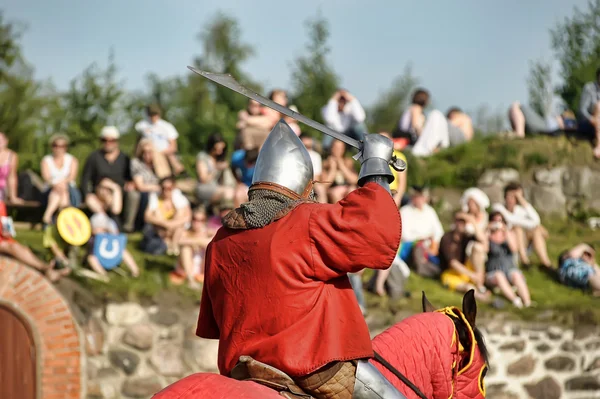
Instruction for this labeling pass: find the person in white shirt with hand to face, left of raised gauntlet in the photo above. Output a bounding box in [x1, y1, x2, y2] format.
[321, 89, 367, 149]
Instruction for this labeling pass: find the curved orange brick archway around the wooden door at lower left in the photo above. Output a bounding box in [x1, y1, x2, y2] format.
[0, 256, 84, 399]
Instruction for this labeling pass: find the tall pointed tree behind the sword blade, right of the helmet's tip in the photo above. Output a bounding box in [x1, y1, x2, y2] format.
[292, 14, 340, 135]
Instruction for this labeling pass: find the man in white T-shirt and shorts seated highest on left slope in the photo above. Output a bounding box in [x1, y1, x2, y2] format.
[135, 104, 185, 178]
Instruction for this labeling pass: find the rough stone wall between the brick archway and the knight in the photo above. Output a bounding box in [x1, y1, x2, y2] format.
[83, 303, 218, 399]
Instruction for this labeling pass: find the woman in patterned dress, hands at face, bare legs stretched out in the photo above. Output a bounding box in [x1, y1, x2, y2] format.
[485, 212, 531, 308]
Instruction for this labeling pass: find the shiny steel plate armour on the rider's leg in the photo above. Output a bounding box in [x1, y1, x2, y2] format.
[352, 360, 406, 399]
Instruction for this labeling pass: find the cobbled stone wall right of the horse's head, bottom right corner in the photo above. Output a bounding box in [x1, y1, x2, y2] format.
[483, 318, 600, 399]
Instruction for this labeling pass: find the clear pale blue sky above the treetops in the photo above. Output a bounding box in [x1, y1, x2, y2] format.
[0, 0, 587, 115]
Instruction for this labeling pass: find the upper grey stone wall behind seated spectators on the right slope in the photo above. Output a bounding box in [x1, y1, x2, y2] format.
[478, 166, 600, 217]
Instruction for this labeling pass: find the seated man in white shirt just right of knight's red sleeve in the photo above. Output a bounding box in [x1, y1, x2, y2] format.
[400, 186, 444, 277]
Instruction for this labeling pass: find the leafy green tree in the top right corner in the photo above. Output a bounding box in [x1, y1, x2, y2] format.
[551, 0, 600, 110]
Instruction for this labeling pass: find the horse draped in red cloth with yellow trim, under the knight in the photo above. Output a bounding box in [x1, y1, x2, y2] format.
[153, 290, 488, 399]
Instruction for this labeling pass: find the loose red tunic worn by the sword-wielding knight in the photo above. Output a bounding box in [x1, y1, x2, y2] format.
[196, 183, 402, 376]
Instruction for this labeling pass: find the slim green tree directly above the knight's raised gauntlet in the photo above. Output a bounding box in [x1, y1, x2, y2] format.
[367, 65, 418, 132]
